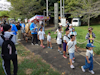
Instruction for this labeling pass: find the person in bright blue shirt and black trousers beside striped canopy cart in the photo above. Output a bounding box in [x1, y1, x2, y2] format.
[30, 20, 38, 45]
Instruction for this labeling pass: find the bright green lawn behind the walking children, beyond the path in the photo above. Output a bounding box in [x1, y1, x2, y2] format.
[46, 25, 100, 55]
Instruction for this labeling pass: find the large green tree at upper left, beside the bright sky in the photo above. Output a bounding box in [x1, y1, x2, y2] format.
[9, 0, 45, 18]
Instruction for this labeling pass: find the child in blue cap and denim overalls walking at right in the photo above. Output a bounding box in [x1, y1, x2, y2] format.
[81, 43, 95, 74]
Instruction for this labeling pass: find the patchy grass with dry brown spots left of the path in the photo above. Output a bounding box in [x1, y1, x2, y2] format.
[0, 44, 61, 75]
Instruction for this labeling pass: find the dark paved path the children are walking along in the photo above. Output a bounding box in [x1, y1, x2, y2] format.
[21, 41, 100, 75]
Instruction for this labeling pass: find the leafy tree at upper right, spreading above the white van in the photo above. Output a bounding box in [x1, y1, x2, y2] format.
[66, 0, 100, 26]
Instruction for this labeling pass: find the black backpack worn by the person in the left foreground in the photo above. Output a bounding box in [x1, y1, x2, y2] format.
[1, 35, 17, 60]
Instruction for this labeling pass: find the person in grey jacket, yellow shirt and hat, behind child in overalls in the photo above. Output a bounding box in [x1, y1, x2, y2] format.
[85, 27, 96, 44]
